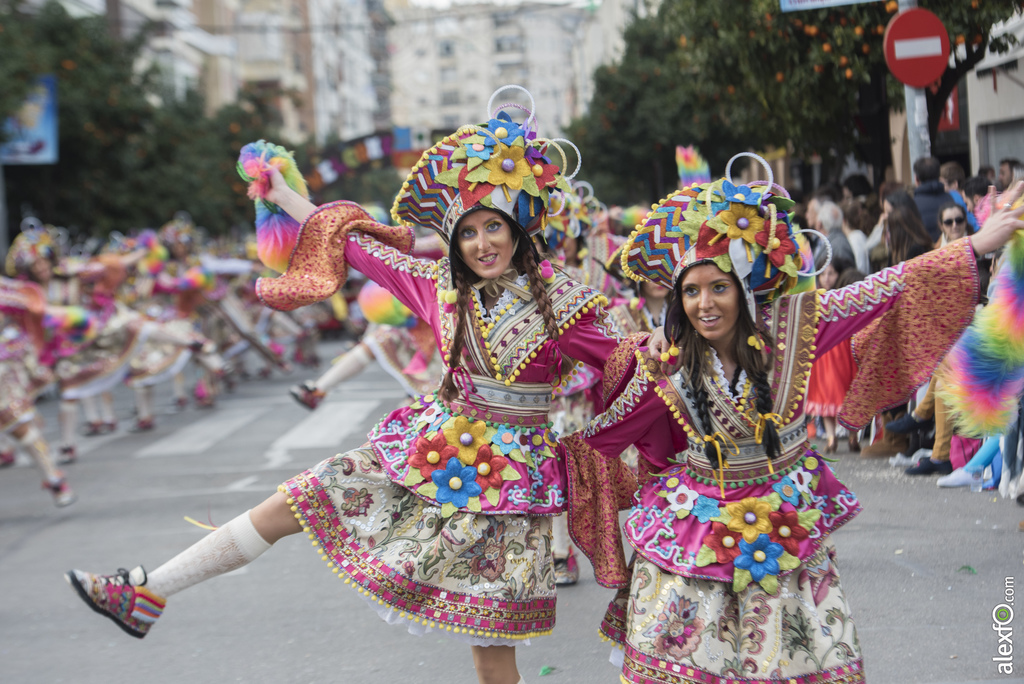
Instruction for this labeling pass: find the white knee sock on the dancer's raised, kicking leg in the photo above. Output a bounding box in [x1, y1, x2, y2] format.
[145, 511, 270, 598]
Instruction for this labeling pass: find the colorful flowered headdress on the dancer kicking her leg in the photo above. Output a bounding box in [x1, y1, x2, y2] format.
[391, 85, 580, 241]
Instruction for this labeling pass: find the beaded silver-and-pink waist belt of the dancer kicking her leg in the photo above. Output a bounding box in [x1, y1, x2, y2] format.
[445, 375, 551, 427]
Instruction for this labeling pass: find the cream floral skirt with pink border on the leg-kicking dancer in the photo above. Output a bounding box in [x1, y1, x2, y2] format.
[280, 445, 555, 645]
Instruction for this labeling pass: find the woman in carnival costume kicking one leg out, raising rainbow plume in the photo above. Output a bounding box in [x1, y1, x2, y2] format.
[68, 87, 629, 684]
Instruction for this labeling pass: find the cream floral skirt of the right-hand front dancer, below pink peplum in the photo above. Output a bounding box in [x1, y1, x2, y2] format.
[601, 544, 864, 684]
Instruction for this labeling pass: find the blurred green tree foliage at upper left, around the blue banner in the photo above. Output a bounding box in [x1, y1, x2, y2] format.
[0, 2, 274, 234]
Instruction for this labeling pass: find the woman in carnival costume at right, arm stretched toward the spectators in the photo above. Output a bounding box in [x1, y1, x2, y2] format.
[564, 156, 1024, 684]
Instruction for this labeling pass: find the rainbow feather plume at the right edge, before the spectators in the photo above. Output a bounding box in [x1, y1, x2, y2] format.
[939, 211, 1024, 437]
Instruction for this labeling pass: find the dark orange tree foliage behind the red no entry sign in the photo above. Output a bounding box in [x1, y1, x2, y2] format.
[569, 0, 1024, 204]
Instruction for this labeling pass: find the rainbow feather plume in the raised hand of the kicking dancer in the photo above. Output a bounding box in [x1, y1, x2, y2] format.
[237, 140, 309, 273]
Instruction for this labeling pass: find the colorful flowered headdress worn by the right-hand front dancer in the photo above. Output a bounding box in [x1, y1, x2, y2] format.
[622, 153, 820, 313]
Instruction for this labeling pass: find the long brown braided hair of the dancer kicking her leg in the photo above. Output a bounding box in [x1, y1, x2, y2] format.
[438, 207, 566, 401]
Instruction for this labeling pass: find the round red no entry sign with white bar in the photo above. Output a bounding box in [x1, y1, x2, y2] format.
[885, 8, 949, 88]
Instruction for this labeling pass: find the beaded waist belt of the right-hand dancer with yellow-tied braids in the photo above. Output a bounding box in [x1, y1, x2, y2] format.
[686, 423, 807, 487]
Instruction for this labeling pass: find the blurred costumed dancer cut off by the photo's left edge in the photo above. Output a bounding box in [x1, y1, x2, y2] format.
[0, 277, 80, 507]
